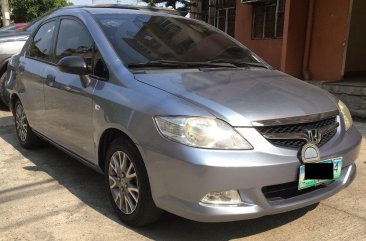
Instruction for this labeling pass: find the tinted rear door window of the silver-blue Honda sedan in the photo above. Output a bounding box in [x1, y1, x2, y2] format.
[29, 21, 56, 61]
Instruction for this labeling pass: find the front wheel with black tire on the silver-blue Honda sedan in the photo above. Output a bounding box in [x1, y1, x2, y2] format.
[104, 138, 162, 227]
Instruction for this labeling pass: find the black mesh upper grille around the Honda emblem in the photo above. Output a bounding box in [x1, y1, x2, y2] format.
[256, 116, 337, 148]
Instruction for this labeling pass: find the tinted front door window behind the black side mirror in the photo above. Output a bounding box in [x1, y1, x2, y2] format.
[56, 19, 94, 73]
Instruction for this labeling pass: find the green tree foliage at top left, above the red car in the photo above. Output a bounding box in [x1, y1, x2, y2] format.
[9, 0, 72, 23]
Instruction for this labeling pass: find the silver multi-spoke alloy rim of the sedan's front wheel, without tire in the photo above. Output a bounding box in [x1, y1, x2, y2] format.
[108, 151, 139, 214]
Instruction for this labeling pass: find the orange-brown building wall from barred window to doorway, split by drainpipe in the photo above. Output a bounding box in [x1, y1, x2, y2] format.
[235, 0, 351, 81]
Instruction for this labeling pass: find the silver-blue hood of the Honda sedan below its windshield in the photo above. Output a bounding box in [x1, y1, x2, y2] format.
[135, 68, 337, 126]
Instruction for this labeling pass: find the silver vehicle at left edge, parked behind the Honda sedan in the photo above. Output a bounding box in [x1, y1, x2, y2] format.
[0, 19, 40, 106]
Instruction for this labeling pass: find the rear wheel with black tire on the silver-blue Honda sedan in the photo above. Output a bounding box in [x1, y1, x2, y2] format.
[13, 100, 43, 149]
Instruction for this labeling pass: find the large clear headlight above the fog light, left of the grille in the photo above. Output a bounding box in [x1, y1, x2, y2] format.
[155, 116, 253, 150]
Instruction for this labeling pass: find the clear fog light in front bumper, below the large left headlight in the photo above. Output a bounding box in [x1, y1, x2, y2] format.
[201, 190, 243, 205]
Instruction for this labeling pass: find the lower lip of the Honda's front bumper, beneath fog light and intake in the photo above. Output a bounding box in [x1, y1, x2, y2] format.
[157, 164, 356, 222]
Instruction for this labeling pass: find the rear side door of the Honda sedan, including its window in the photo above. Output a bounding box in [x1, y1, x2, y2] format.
[17, 20, 56, 134]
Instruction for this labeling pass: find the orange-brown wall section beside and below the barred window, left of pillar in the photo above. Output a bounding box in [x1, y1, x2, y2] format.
[235, 0, 282, 69]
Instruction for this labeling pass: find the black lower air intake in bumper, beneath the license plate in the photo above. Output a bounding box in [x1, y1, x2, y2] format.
[262, 182, 325, 202]
